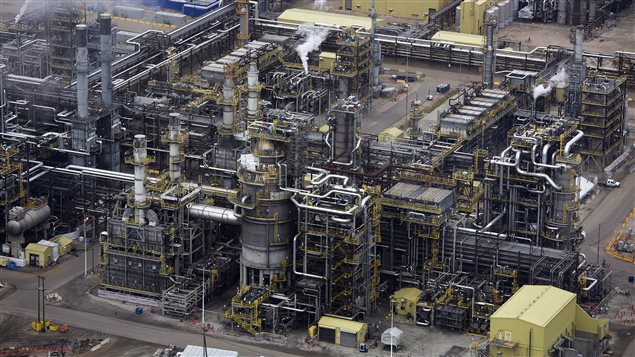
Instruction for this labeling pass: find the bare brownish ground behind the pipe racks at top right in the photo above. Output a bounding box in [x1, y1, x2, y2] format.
[496, 7, 635, 53]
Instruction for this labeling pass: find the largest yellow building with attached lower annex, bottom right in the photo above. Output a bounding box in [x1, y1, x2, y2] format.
[490, 285, 608, 357]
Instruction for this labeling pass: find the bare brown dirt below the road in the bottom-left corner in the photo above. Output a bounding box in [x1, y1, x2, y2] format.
[0, 314, 159, 357]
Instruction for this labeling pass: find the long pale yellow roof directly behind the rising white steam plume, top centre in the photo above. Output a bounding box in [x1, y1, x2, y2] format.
[278, 9, 384, 30]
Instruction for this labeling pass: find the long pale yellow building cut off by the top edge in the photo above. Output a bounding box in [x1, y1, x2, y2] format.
[342, 0, 451, 20]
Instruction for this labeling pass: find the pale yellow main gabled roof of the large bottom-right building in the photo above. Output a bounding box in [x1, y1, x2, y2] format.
[491, 285, 575, 327]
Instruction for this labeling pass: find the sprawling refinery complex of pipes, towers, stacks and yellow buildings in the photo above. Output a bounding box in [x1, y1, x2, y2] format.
[0, 0, 635, 356]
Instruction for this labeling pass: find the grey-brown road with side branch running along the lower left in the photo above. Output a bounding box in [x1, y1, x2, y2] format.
[0, 251, 304, 357]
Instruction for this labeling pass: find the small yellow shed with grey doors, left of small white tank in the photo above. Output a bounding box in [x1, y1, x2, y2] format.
[318, 316, 368, 347]
